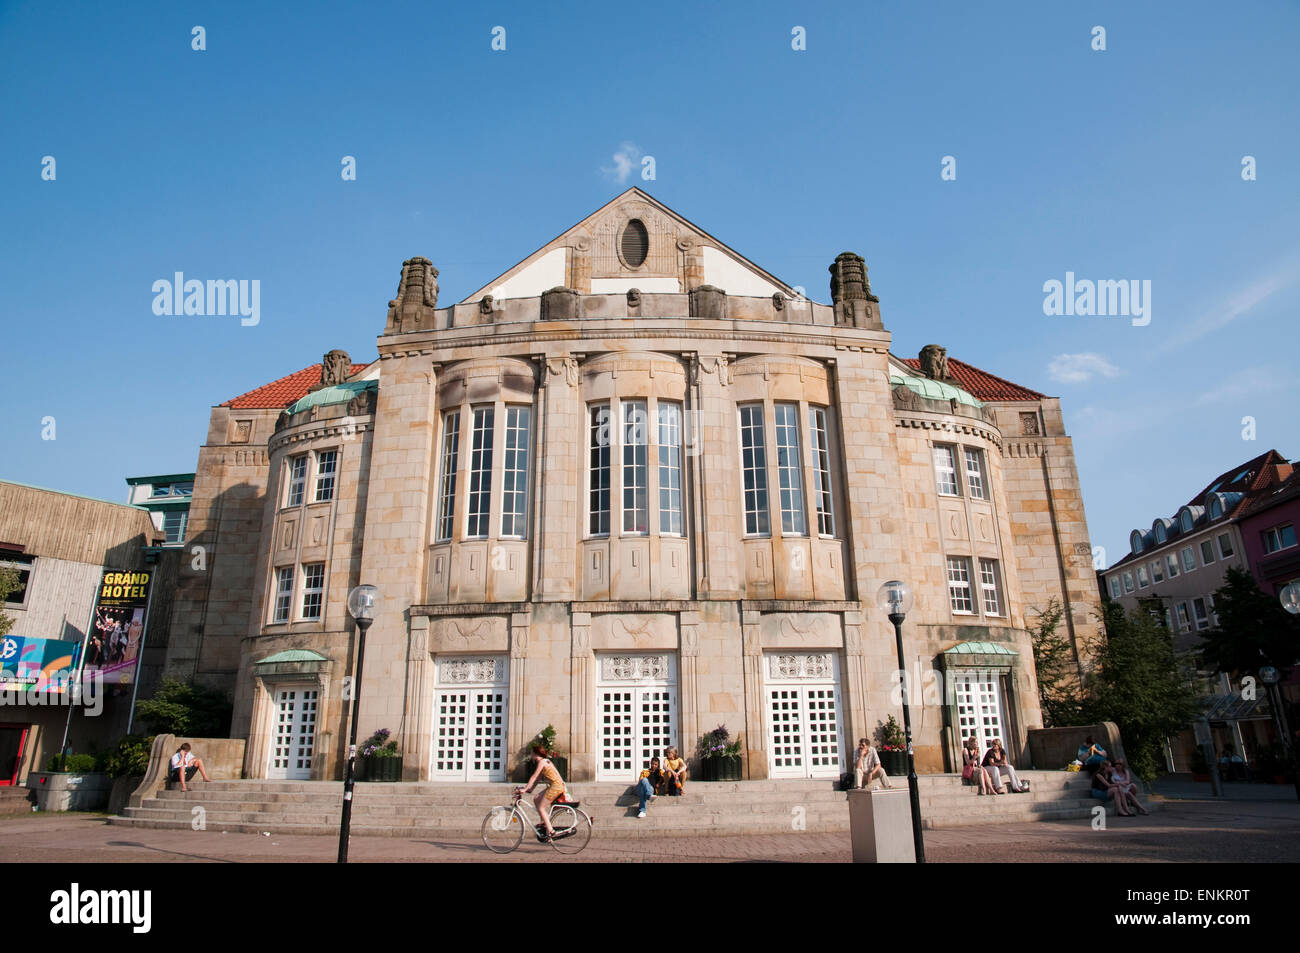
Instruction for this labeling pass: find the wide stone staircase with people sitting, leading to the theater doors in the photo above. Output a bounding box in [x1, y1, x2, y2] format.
[111, 771, 1156, 837]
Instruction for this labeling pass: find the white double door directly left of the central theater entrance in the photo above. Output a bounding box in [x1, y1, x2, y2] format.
[429, 657, 510, 781]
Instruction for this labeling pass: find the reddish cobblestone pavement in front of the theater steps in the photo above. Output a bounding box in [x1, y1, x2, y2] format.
[0, 801, 1300, 863]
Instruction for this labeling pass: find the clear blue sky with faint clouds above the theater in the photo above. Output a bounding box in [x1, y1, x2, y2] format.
[0, 1, 1300, 562]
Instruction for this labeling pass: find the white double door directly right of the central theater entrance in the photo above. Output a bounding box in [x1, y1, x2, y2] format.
[763, 651, 844, 777]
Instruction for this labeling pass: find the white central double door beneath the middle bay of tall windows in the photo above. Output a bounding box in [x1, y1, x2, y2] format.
[595, 654, 677, 781]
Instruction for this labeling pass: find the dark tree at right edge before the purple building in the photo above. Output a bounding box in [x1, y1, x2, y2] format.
[1197, 567, 1300, 675]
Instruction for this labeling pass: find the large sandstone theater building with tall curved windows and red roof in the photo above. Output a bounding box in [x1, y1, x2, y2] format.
[168, 190, 1097, 783]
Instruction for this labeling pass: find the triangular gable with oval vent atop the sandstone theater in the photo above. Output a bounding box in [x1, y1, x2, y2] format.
[462, 187, 798, 304]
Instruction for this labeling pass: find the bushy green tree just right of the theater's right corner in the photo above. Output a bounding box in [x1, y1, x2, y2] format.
[1086, 602, 1201, 781]
